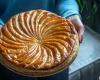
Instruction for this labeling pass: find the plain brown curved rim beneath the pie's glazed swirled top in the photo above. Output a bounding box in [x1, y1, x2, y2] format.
[0, 47, 78, 77]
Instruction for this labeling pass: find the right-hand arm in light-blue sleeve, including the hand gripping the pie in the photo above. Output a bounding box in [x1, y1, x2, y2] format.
[56, 0, 84, 43]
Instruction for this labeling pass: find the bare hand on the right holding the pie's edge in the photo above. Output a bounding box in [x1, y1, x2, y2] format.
[68, 15, 85, 43]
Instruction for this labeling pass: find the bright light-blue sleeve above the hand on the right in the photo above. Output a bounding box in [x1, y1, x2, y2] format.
[56, 0, 79, 18]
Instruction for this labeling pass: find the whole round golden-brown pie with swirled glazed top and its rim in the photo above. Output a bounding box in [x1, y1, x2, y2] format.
[0, 10, 79, 77]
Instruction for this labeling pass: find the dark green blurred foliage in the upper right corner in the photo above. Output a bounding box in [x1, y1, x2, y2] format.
[77, 0, 100, 34]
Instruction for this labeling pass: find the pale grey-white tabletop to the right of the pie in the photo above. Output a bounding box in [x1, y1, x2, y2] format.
[69, 27, 100, 74]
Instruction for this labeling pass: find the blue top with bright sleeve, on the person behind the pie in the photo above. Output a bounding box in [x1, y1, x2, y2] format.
[0, 0, 79, 22]
